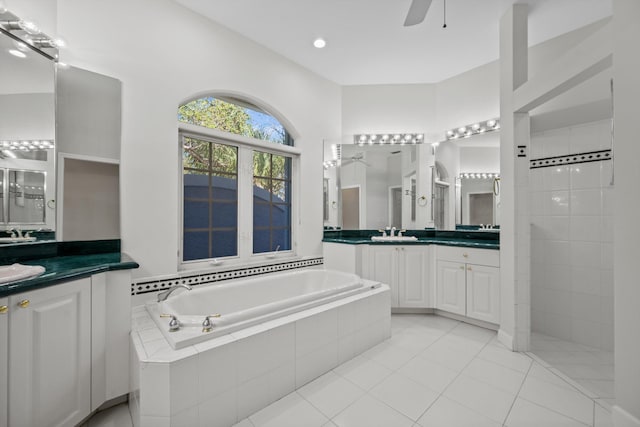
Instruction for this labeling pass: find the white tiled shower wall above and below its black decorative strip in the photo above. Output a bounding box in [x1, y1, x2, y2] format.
[529, 120, 613, 351]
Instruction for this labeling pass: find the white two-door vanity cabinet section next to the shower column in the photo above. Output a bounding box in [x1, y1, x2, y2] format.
[436, 246, 500, 324]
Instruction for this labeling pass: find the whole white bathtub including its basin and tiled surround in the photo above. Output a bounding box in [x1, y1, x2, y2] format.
[129, 270, 391, 427]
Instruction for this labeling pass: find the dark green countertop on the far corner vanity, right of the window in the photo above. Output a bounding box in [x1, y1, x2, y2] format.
[322, 230, 500, 249]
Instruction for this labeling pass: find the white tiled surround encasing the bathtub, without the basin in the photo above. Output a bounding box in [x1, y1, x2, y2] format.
[130, 276, 390, 427]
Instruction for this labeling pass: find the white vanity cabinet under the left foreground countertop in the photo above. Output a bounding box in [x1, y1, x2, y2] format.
[0, 270, 131, 427]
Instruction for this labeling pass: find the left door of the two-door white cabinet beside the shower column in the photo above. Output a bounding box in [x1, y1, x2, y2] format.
[436, 261, 466, 316]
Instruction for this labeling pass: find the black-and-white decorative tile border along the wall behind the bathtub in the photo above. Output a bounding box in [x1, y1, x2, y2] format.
[131, 257, 324, 295]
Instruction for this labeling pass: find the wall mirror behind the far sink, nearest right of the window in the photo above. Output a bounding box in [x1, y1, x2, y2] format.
[324, 138, 431, 230]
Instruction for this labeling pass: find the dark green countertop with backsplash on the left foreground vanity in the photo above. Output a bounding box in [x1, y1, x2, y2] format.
[0, 241, 139, 297]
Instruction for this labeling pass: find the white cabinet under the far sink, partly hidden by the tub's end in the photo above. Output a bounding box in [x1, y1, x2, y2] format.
[364, 245, 430, 308]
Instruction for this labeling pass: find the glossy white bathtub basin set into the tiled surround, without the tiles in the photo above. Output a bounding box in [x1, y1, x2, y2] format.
[146, 270, 380, 349]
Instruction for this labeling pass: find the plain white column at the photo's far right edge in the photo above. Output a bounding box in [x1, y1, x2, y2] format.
[613, 0, 640, 427]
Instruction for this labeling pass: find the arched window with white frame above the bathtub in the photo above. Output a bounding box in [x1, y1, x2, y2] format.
[178, 96, 299, 264]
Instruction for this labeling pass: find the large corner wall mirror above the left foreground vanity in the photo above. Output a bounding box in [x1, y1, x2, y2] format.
[0, 11, 121, 245]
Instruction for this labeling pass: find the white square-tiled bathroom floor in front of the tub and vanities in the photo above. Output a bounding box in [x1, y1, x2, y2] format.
[86, 315, 612, 427]
